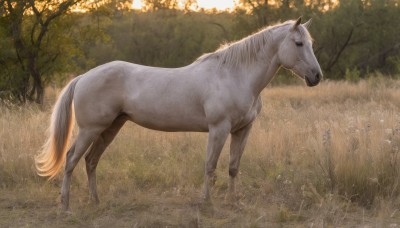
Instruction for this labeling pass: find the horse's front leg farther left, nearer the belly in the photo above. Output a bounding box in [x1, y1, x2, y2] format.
[203, 122, 230, 202]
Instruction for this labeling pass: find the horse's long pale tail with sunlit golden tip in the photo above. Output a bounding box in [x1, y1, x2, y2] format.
[35, 77, 80, 179]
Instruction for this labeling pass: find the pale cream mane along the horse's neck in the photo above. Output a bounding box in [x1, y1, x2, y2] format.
[196, 21, 294, 67]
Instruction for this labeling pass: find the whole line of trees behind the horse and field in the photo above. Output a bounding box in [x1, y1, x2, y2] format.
[0, 0, 400, 103]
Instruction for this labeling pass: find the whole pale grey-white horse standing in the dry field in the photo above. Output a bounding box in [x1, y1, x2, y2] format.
[35, 18, 322, 210]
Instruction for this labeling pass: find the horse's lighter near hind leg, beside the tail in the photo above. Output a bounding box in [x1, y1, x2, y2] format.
[61, 129, 98, 211]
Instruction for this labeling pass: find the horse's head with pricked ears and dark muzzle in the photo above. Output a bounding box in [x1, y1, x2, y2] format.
[278, 18, 322, 86]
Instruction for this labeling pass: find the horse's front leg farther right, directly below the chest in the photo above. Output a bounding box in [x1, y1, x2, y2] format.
[225, 123, 252, 203]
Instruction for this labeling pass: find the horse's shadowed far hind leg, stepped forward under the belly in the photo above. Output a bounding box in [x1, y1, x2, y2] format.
[85, 115, 127, 203]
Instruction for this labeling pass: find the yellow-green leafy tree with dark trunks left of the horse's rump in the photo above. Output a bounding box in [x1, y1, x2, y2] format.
[0, 0, 111, 103]
